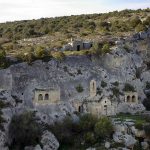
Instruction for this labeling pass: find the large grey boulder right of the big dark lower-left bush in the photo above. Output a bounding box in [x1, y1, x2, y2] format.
[41, 131, 59, 150]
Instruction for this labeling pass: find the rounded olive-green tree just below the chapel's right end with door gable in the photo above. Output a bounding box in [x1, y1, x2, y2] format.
[94, 117, 113, 139]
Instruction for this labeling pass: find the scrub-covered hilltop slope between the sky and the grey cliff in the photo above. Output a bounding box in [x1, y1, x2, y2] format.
[0, 8, 150, 68]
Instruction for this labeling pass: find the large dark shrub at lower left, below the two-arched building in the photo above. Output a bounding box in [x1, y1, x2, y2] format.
[9, 112, 42, 150]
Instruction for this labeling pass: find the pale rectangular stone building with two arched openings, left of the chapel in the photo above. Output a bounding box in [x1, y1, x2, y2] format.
[33, 89, 60, 105]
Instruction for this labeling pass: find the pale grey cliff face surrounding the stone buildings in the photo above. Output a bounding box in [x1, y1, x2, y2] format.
[0, 29, 150, 147]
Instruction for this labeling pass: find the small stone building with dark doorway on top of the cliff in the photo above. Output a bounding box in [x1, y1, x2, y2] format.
[62, 39, 93, 51]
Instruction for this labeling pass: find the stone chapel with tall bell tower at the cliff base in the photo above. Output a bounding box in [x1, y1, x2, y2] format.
[73, 80, 116, 117]
